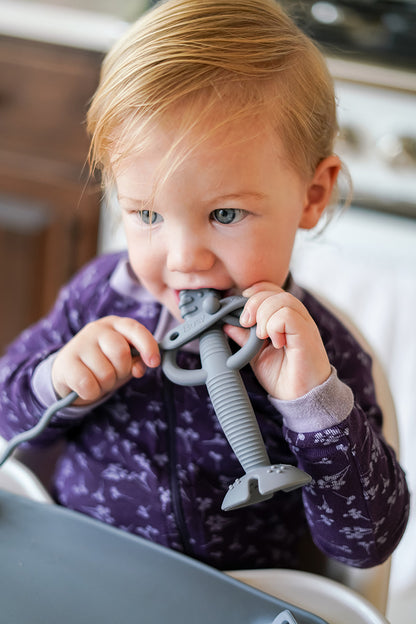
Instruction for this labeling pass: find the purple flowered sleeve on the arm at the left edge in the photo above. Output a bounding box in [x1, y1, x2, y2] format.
[0, 258, 121, 444]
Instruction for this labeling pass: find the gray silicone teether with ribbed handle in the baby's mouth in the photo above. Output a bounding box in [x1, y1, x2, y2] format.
[161, 289, 311, 510]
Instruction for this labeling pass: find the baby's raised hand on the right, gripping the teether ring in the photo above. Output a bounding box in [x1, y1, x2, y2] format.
[226, 282, 331, 400]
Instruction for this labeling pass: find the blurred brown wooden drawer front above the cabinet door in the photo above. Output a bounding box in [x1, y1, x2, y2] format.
[0, 37, 101, 164]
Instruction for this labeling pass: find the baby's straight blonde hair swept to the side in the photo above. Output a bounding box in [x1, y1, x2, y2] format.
[87, 0, 338, 200]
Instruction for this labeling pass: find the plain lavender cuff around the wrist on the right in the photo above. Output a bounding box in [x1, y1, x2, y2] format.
[269, 367, 354, 433]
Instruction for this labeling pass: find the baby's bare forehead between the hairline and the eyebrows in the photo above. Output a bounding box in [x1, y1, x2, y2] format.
[113, 112, 293, 207]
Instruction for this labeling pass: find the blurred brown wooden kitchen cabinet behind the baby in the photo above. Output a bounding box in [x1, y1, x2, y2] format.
[0, 37, 102, 351]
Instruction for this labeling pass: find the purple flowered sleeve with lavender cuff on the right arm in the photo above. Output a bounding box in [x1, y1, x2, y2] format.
[277, 290, 409, 568]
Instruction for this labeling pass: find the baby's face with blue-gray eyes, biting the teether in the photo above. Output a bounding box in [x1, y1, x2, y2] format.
[114, 116, 314, 318]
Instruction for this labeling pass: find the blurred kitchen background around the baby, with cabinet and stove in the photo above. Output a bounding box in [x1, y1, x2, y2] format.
[0, 0, 416, 624]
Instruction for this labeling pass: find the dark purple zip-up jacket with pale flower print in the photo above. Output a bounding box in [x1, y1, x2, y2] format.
[0, 254, 409, 569]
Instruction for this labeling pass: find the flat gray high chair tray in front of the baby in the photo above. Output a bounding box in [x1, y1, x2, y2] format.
[0, 491, 324, 624]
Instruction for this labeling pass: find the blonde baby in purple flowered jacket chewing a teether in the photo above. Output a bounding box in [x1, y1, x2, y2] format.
[0, 0, 409, 569]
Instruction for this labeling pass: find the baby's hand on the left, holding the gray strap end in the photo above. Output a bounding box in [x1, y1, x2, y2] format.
[52, 316, 160, 405]
